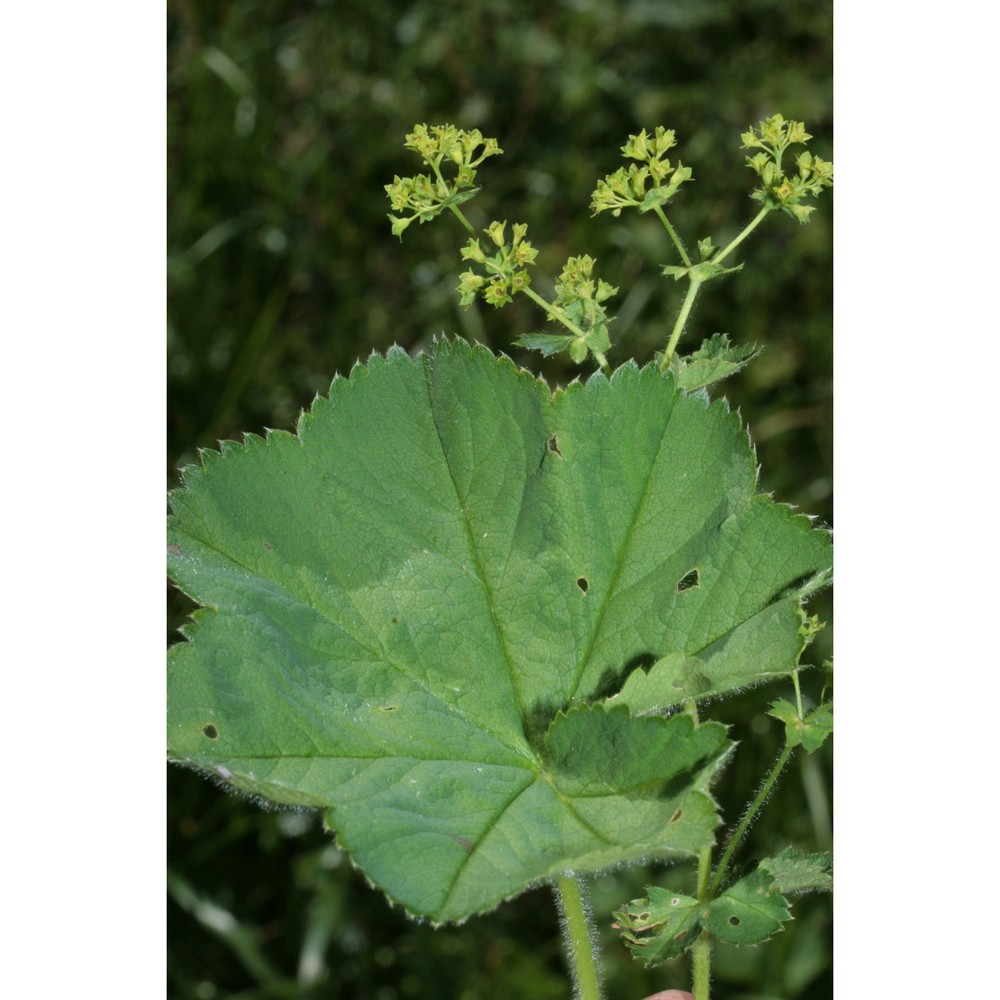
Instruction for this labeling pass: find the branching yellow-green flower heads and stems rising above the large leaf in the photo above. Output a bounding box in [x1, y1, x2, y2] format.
[385, 115, 833, 377]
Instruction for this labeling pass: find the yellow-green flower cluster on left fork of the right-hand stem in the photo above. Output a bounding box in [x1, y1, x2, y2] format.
[590, 125, 691, 216]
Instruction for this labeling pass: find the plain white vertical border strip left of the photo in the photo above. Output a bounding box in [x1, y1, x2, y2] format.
[0, 2, 166, 1000]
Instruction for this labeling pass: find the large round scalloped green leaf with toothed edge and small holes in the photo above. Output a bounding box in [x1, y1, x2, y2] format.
[169, 343, 830, 921]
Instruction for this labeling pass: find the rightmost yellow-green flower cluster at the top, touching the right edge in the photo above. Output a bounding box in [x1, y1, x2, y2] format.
[741, 115, 833, 222]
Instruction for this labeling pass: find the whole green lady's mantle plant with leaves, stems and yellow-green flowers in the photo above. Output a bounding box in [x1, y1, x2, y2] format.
[168, 115, 833, 1000]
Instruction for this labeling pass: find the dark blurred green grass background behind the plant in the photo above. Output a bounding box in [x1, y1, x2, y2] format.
[167, 0, 833, 1000]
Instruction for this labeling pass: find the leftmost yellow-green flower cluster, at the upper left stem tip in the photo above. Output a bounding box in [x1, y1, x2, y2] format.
[385, 125, 503, 239]
